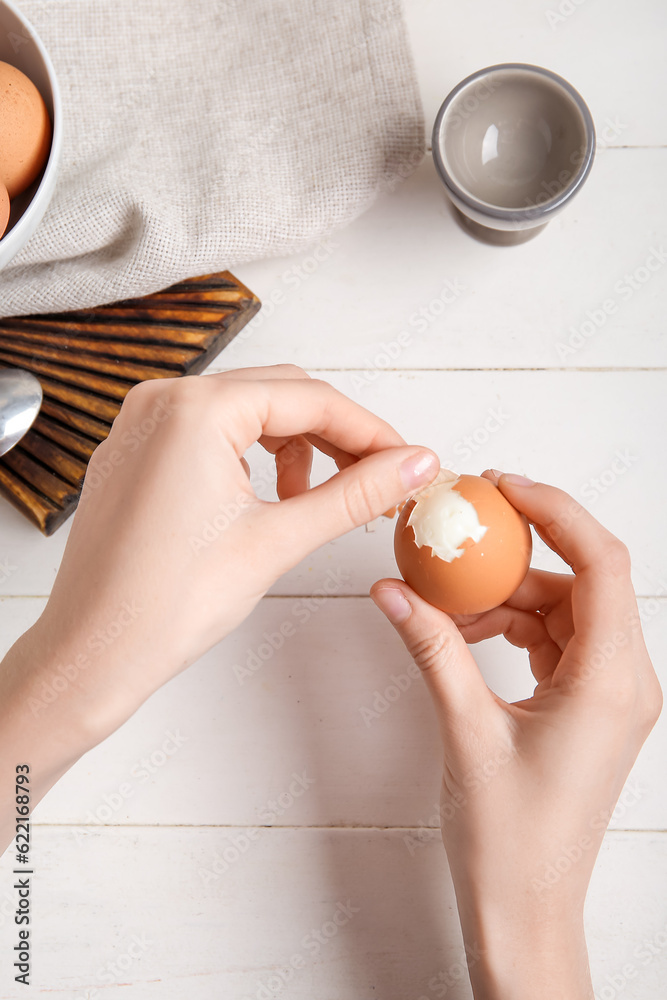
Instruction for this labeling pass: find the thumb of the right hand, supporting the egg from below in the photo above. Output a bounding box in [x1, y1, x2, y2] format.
[371, 580, 495, 738]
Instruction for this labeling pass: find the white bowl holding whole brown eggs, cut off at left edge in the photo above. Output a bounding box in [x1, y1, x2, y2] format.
[0, 0, 62, 270]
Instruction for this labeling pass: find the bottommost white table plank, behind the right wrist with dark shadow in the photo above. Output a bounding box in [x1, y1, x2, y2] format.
[0, 824, 667, 1000]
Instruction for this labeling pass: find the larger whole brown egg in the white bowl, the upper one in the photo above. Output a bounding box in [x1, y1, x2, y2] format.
[0, 62, 51, 198]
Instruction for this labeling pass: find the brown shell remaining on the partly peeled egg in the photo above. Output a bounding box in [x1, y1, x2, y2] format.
[394, 476, 532, 615]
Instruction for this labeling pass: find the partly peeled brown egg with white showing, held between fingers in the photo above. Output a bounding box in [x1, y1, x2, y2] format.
[394, 470, 532, 615]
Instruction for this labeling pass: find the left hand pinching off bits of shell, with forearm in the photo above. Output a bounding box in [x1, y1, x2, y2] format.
[0, 366, 439, 846]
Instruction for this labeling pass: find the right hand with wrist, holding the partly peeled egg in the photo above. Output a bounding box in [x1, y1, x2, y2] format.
[371, 472, 662, 1000]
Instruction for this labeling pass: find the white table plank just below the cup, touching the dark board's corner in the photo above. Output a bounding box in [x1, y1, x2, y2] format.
[230, 154, 667, 378]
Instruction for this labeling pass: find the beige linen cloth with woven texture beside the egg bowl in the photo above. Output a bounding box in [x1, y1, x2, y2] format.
[0, 0, 424, 316]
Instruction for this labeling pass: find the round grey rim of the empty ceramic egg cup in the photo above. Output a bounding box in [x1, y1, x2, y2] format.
[431, 62, 596, 225]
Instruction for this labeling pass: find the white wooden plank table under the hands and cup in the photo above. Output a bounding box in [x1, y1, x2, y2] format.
[0, 0, 667, 1000]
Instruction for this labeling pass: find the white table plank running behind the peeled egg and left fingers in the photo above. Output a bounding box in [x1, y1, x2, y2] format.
[0, 372, 667, 596]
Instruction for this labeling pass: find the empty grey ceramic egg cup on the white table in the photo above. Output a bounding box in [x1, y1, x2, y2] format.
[433, 63, 595, 245]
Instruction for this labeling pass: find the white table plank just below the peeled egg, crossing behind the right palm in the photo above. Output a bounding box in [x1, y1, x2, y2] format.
[7, 592, 667, 830]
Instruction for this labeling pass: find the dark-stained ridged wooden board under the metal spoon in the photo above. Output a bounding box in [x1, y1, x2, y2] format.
[0, 271, 260, 535]
